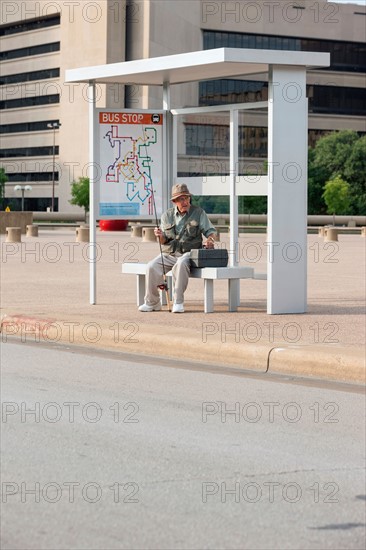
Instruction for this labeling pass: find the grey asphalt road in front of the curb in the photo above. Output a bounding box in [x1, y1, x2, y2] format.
[1, 341, 366, 550]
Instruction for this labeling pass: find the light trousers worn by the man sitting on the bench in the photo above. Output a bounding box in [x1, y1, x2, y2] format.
[145, 252, 190, 306]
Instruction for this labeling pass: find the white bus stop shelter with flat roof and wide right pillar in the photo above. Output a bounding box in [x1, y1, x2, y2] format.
[65, 48, 330, 314]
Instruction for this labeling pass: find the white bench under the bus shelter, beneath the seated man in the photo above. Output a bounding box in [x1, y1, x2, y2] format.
[122, 262, 267, 313]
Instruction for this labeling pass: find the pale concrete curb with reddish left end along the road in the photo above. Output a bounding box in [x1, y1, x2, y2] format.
[0, 314, 366, 384]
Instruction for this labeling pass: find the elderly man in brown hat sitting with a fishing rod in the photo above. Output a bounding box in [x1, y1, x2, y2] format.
[139, 184, 216, 313]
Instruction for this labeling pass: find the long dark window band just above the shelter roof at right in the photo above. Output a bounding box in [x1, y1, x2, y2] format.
[203, 31, 366, 73]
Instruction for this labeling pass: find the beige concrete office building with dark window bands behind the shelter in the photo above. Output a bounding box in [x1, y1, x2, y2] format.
[0, 0, 366, 211]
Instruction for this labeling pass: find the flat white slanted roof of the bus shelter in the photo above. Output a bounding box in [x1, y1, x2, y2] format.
[65, 48, 330, 86]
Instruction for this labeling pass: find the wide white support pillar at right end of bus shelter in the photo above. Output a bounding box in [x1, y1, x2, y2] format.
[267, 65, 308, 314]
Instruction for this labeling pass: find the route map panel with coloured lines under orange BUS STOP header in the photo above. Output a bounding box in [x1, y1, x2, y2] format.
[98, 111, 163, 218]
